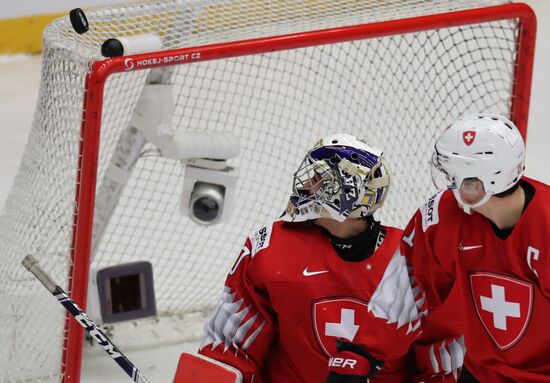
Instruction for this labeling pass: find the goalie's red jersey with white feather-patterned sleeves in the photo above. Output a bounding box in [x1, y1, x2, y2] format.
[200, 222, 420, 383]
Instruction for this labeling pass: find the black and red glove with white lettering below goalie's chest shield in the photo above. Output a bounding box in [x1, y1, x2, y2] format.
[326, 339, 384, 383]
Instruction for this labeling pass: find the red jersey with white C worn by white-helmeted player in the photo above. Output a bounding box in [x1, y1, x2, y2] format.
[403, 178, 550, 383]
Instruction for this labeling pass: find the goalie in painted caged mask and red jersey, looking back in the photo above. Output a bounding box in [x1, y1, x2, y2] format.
[200, 134, 430, 383]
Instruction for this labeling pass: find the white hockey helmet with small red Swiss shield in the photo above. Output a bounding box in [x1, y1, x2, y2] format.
[432, 114, 525, 213]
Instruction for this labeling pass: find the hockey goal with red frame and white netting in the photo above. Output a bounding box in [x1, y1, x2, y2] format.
[0, 0, 536, 382]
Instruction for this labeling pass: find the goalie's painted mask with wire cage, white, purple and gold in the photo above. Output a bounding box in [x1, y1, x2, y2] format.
[281, 134, 390, 222]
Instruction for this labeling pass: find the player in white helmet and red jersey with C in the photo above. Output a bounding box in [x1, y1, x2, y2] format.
[402, 114, 550, 383]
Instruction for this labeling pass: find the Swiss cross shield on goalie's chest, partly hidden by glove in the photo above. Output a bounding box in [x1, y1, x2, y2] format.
[312, 297, 368, 357]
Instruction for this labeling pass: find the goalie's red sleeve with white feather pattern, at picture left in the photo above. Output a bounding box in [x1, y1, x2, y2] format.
[199, 229, 278, 383]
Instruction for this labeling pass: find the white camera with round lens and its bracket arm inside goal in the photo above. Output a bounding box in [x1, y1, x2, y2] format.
[130, 79, 240, 225]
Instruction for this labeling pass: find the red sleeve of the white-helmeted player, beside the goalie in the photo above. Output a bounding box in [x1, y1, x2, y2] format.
[401, 198, 465, 382]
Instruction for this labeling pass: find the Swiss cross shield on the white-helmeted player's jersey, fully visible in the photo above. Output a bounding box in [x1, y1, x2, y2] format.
[470, 272, 533, 350]
